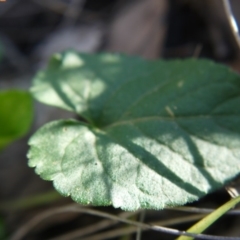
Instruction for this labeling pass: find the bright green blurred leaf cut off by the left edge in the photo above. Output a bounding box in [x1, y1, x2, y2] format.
[0, 90, 33, 150]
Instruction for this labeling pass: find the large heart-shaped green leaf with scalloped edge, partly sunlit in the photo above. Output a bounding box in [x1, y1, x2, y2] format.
[28, 52, 240, 210]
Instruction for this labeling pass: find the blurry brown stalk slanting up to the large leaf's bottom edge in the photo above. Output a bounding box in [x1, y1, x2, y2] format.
[51, 212, 141, 240]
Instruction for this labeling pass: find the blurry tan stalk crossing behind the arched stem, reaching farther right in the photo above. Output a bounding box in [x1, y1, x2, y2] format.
[79, 214, 205, 240]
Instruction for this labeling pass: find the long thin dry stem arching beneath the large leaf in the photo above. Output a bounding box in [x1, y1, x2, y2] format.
[10, 204, 240, 240]
